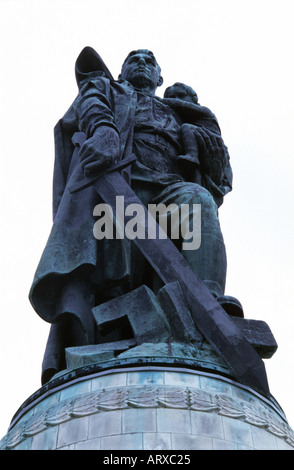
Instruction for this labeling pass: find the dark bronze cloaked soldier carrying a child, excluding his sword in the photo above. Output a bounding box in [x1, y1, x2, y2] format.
[30, 47, 240, 383]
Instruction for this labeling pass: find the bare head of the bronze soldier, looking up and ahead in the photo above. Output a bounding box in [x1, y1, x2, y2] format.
[119, 49, 163, 94]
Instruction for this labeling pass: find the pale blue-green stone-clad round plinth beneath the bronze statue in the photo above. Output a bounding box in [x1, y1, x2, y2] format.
[0, 364, 294, 450]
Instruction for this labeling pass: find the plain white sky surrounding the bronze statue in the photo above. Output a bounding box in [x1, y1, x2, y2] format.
[0, 0, 294, 438]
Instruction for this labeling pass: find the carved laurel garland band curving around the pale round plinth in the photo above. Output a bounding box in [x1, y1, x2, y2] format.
[0, 386, 294, 450]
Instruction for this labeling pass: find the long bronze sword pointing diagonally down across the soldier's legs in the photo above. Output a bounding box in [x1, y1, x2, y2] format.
[70, 135, 270, 396]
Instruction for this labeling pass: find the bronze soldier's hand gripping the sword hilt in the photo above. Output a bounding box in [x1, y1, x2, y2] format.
[79, 126, 120, 176]
